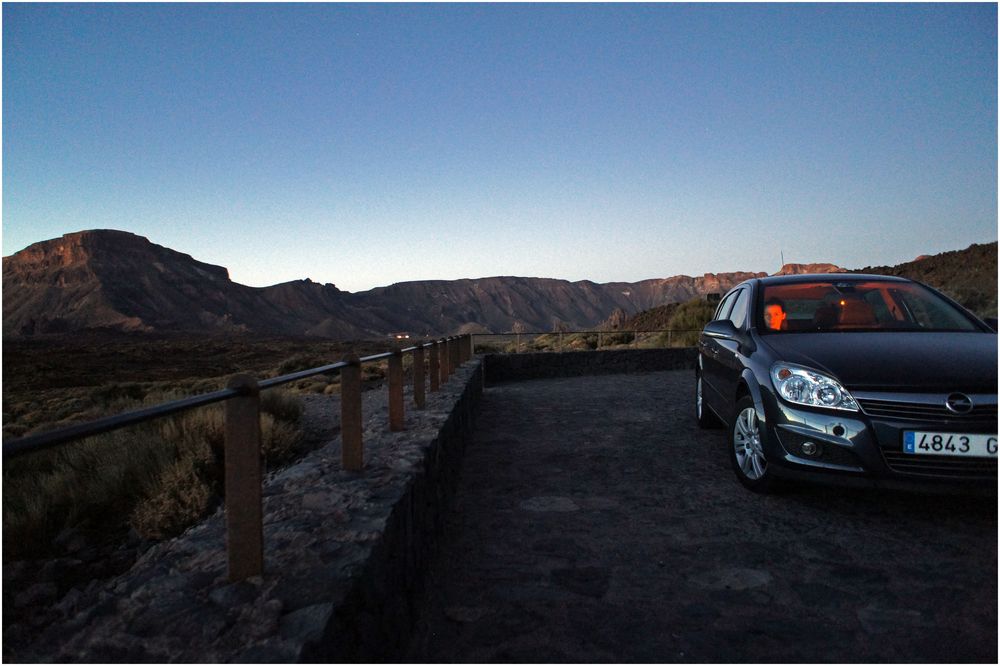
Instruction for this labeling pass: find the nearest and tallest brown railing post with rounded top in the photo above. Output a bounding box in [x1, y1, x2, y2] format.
[225, 375, 264, 583]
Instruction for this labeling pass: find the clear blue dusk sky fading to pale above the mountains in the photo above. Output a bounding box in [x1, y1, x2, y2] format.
[2, 3, 998, 291]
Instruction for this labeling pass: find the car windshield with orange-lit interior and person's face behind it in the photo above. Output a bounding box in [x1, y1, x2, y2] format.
[757, 280, 979, 333]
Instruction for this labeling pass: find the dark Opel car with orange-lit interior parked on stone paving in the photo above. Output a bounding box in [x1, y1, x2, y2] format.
[695, 273, 997, 493]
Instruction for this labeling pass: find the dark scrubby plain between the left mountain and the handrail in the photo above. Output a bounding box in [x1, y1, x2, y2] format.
[3, 333, 393, 437]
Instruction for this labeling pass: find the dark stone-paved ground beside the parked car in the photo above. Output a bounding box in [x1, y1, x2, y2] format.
[400, 371, 997, 663]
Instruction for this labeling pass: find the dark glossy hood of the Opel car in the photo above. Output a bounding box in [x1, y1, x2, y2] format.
[762, 331, 997, 393]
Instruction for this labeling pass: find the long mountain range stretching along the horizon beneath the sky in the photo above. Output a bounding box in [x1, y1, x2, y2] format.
[3, 230, 996, 339]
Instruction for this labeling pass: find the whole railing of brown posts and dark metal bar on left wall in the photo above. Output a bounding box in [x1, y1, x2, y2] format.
[3, 335, 473, 582]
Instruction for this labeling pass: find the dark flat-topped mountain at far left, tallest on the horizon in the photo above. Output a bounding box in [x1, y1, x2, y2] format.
[3, 230, 381, 336]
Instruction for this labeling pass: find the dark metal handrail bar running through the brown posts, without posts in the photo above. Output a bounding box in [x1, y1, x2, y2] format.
[3, 337, 454, 460]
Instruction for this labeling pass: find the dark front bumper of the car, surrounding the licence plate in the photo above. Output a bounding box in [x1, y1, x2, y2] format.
[762, 392, 997, 490]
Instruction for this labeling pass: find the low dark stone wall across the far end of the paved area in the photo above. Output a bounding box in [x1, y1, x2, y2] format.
[484, 347, 698, 384]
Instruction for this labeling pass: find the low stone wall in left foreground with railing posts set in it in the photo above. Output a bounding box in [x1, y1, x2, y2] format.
[4, 359, 483, 662]
